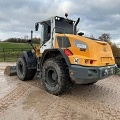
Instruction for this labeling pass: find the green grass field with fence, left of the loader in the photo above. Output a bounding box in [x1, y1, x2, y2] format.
[0, 42, 37, 62]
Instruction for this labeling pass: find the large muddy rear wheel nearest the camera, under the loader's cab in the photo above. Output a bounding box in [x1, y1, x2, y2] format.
[42, 58, 72, 95]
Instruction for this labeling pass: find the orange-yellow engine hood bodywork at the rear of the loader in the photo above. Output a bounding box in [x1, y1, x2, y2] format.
[55, 34, 115, 66]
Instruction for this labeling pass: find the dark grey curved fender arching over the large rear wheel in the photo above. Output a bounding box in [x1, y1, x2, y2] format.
[40, 48, 70, 68]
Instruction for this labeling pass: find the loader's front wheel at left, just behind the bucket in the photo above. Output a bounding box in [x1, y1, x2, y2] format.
[16, 58, 36, 81]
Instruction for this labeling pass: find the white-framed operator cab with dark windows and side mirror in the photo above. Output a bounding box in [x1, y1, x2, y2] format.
[35, 16, 80, 53]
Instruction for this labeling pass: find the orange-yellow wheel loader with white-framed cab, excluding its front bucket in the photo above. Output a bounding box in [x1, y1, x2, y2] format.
[16, 14, 117, 95]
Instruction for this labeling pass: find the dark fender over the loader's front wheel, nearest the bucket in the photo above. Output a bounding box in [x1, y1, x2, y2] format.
[21, 51, 37, 69]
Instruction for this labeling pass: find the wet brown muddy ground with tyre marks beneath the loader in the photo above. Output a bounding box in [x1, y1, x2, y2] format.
[0, 63, 120, 120]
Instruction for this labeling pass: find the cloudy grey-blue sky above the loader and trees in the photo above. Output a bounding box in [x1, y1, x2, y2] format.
[0, 0, 120, 42]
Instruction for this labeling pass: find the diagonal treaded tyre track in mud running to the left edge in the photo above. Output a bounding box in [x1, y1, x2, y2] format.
[0, 83, 31, 114]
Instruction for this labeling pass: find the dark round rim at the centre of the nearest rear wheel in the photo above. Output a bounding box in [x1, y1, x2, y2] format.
[46, 67, 58, 86]
